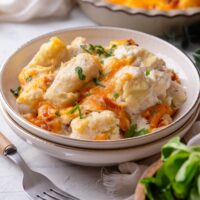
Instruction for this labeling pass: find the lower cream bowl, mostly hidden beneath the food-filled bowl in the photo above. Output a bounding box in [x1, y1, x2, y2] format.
[0, 102, 199, 166]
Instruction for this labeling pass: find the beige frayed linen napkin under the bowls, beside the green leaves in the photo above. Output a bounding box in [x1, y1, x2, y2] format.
[102, 121, 200, 200]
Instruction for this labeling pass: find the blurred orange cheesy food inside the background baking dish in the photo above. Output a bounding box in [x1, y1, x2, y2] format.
[105, 0, 200, 10]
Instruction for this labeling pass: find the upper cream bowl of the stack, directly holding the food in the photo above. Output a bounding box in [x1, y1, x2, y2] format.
[0, 27, 200, 149]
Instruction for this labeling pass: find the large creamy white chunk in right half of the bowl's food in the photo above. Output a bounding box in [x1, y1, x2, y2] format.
[115, 66, 158, 115]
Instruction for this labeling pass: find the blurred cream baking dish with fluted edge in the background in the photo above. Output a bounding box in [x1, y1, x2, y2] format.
[78, 0, 200, 36]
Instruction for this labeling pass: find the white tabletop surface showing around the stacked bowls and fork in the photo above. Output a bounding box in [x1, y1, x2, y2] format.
[0, 8, 115, 200]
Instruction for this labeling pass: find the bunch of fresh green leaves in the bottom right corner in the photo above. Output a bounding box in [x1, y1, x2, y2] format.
[141, 137, 200, 200]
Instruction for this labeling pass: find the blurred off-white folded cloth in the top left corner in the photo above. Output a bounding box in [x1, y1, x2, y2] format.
[0, 0, 73, 22]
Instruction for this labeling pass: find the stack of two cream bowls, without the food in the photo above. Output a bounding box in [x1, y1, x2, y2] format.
[0, 27, 200, 166]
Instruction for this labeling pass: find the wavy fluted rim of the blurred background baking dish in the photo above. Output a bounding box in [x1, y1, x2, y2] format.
[78, 0, 200, 18]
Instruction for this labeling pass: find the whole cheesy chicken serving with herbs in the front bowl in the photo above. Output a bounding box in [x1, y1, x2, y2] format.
[11, 37, 186, 140]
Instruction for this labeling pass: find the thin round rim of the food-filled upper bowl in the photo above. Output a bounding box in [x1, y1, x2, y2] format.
[0, 26, 200, 144]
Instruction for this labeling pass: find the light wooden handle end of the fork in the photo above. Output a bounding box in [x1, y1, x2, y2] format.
[0, 132, 17, 156]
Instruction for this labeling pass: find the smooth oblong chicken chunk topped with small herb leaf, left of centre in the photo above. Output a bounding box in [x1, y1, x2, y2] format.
[44, 53, 101, 106]
